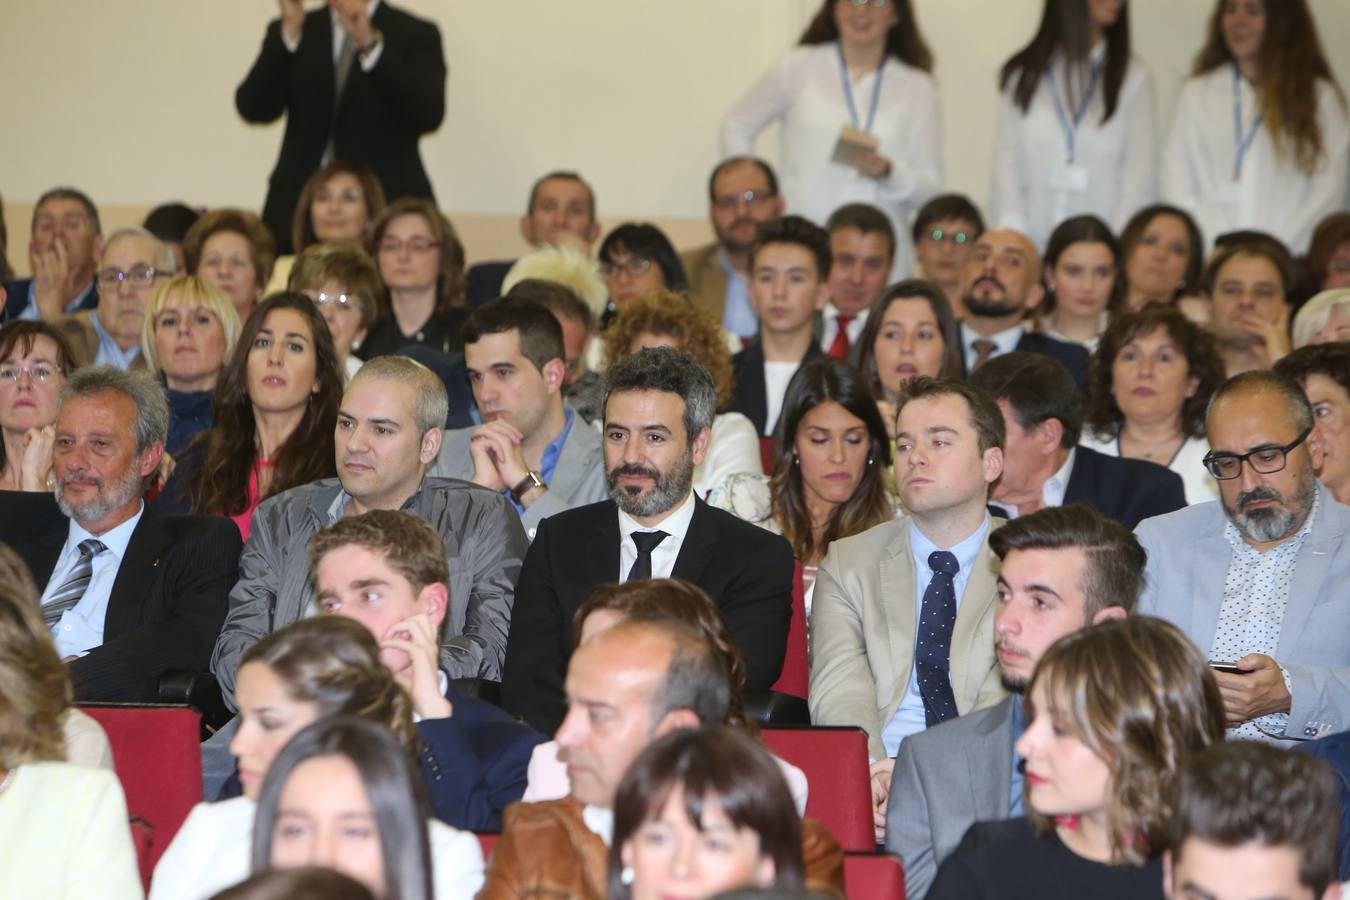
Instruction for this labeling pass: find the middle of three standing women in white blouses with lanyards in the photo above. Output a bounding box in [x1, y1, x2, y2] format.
[990, 0, 1157, 253]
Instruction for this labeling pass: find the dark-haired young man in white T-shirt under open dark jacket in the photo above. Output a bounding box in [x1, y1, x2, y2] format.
[730, 216, 832, 437]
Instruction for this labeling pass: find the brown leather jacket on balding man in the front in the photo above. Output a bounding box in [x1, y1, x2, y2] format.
[478, 797, 844, 900]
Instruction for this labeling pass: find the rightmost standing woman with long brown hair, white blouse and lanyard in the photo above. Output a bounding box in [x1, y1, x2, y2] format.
[1162, 0, 1350, 254]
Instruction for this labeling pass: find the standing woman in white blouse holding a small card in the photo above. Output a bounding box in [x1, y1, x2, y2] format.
[722, 0, 942, 274]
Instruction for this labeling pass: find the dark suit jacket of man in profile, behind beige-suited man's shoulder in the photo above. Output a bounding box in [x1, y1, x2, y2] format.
[990, 447, 1185, 532]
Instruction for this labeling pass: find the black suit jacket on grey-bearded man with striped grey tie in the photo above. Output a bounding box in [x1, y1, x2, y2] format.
[0, 491, 243, 703]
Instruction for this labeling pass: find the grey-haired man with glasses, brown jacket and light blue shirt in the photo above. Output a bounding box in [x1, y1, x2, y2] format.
[54, 227, 173, 370]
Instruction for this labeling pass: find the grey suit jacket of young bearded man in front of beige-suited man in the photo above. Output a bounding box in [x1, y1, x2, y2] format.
[886, 698, 1014, 900]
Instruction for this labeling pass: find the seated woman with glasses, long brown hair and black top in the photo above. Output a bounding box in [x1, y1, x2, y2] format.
[360, 197, 468, 359]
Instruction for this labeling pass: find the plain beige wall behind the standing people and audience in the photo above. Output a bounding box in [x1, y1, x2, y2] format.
[0, 0, 1350, 275]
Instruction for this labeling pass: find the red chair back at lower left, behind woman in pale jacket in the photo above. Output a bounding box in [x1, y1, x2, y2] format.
[80, 706, 201, 889]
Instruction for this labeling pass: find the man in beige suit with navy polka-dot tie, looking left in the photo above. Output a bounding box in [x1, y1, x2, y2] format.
[807, 375, 1003, 775]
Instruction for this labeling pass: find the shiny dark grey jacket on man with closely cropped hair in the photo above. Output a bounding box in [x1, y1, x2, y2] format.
[211, 478, 529, 702]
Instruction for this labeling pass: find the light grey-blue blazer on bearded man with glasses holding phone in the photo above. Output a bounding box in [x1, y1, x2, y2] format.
[1135, 486, 1350, 741]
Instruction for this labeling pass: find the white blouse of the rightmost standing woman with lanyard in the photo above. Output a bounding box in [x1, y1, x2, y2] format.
[1162, 66, 1350, 255]
